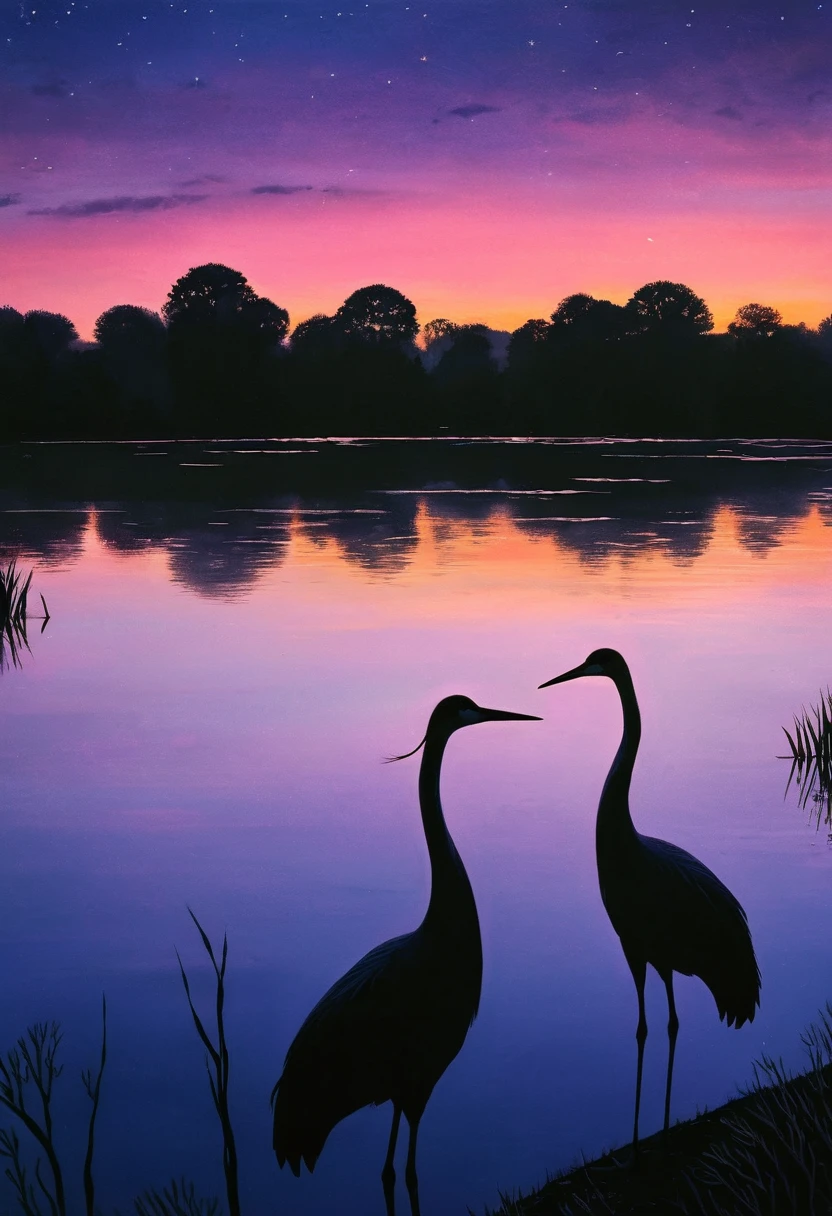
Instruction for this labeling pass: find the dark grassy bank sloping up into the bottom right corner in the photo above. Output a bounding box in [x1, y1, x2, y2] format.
[489, 1004, 832, 1216]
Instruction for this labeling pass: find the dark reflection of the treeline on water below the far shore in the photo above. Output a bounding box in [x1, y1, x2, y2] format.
[0, 440, 832, 596]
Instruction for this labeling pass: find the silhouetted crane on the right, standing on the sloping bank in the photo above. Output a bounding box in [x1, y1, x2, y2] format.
[540, 649, 760, 1160]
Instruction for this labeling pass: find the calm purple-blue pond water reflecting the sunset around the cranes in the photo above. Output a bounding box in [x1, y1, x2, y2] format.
[0, 440, 832, 1216]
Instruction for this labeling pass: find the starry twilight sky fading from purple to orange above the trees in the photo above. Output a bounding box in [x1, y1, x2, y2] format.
[0, 0, 832, 336]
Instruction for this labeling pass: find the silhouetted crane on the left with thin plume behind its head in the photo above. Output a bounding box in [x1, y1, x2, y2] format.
[271, 697, 540, 1216]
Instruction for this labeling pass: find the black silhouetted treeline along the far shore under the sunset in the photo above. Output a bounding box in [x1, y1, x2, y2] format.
[0, 263, 832, 440]
